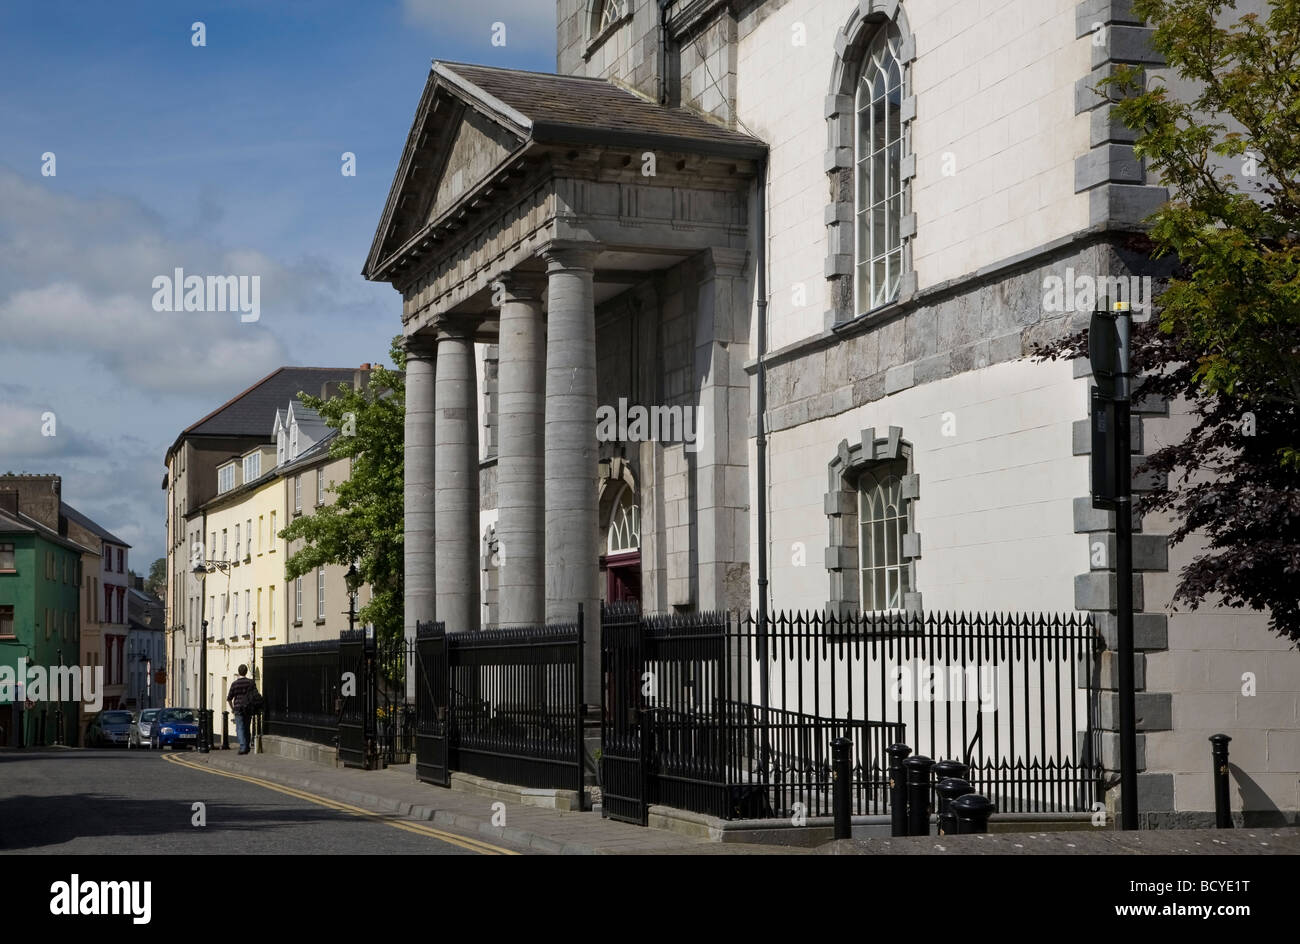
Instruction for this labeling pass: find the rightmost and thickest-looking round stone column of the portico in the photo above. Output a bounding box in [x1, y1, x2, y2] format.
[542, 243, 601, 703]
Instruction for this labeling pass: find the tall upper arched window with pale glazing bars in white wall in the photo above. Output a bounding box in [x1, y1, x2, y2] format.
[854, 29, 904, 315]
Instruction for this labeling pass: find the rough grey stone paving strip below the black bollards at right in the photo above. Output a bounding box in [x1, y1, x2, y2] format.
[816, 827, 1300, 856]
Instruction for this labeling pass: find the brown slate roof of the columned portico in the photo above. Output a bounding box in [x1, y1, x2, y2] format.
[433, 61, 767, 157]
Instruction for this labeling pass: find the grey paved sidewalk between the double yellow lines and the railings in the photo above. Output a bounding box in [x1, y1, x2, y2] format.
[172, 750, 810, 856]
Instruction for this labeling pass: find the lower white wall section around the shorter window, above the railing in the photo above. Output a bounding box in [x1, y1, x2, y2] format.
[750, 360, 1088, 612]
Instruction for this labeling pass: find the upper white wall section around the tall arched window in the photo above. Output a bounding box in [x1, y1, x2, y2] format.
[737, 0, 1091, 350]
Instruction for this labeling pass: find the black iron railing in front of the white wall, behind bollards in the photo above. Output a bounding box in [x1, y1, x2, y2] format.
[602, 606, 1100, 822]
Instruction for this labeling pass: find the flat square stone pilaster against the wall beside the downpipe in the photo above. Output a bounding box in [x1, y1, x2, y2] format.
[686, 248, 749, 610]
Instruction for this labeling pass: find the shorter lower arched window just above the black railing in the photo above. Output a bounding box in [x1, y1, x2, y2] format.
[858, 460, 911, 611]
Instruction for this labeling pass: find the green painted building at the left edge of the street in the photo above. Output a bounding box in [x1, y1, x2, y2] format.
[0, 493, 86, 746]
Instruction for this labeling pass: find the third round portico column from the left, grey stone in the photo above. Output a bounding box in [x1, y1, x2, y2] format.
[497, 273, 546, 627]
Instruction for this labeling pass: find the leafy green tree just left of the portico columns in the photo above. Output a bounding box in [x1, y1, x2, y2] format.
[280, 337, 406, 638]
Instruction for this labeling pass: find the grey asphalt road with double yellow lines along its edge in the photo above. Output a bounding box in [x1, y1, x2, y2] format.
[0, 749, 525, 856]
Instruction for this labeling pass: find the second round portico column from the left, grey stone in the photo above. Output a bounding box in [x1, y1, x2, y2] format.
[433, 328, 480, 632]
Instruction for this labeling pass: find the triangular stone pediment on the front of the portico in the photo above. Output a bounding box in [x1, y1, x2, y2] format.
[363, 65, 529, 277]
